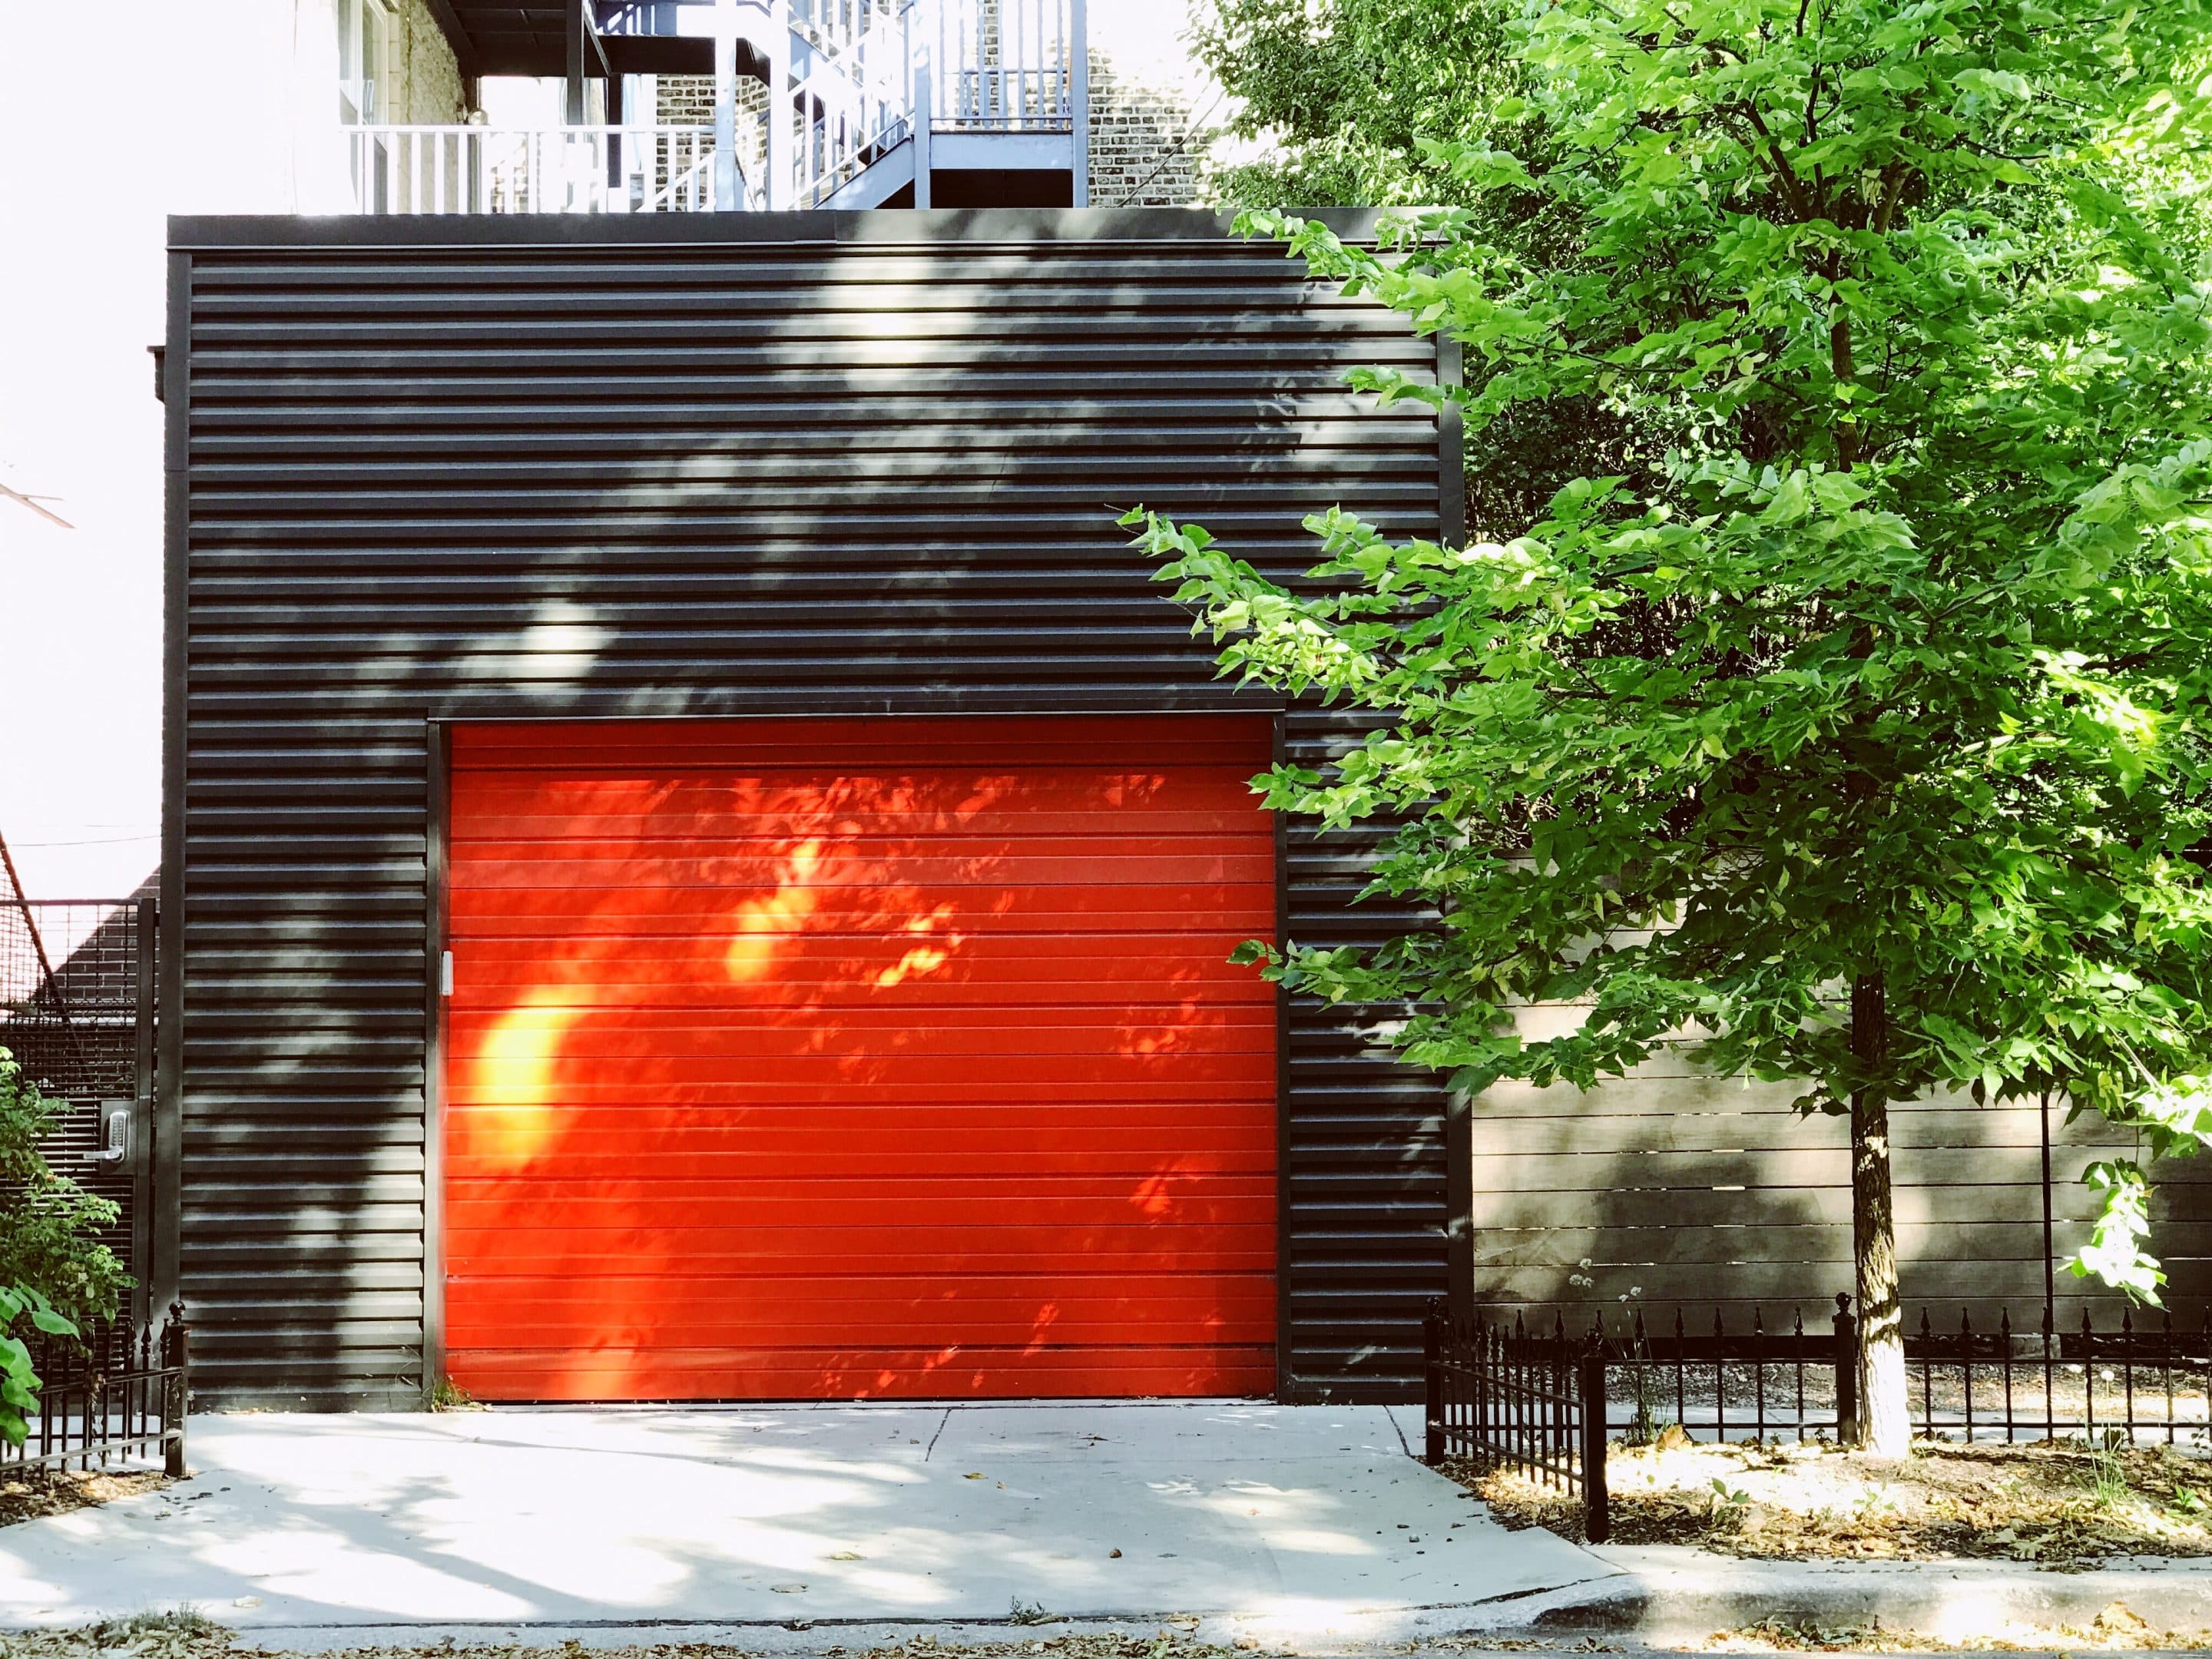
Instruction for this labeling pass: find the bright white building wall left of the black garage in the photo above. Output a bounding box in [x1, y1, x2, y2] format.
[0, 0, 460, 898]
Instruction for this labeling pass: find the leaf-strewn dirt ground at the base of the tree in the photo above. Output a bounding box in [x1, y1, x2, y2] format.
[1445, 1431, 2212, 1568]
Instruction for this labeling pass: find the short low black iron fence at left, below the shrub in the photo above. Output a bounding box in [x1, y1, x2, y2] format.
[0, 1303, 193, 1478]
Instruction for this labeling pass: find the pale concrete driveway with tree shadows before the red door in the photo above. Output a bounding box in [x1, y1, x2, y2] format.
[0, 1402, 1614, 1646]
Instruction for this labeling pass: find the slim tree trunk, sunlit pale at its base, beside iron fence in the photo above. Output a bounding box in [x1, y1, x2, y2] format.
[1852, 973, 1913, 1458]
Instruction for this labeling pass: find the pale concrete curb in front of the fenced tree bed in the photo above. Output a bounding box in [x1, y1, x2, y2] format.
[1465, 1544, 2212, 1646]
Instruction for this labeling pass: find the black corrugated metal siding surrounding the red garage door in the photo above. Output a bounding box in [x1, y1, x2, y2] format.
[171, 212, 1445, 1405]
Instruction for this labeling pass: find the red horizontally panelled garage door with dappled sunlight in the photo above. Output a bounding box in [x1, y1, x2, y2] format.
[445, 717, 1277, 1400]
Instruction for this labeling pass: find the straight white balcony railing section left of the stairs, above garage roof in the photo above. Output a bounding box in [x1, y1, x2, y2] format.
[345, 126, 720, 212]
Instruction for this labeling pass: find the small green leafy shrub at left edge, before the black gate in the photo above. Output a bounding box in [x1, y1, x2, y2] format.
[0, 1048, 131, 1447]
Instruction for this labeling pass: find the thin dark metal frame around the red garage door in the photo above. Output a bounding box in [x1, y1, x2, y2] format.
[422, 699, 1294, 1400]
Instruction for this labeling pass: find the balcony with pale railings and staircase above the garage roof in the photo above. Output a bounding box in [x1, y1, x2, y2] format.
[345, 0, 1088, 214]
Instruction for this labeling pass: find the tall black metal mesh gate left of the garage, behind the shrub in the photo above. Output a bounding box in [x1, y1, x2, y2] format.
[0, 898, 155, 1330]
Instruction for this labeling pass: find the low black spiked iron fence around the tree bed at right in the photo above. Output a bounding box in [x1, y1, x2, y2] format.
[1425, 1296, 2212, 1544]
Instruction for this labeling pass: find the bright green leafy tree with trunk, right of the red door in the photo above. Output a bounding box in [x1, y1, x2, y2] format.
[1133, 0, 2212, 1453]
